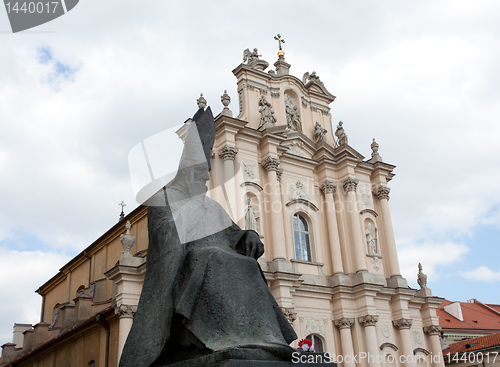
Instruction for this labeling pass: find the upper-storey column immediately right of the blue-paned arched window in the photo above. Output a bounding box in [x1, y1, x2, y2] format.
[319, 180, 344, 274]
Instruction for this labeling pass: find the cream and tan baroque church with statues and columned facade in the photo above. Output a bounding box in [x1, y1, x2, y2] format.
[0, 47, 444, 367]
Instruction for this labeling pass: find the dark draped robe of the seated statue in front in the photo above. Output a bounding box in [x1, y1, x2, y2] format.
[120, 190, 297, 367]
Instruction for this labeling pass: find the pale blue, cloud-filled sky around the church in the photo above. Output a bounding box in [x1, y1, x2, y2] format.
[0, 0, 500, 345]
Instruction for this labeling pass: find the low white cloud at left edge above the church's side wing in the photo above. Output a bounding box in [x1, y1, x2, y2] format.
[0, 247, 71, 344]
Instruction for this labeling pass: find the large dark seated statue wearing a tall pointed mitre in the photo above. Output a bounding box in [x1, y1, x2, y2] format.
[119, 108, 297, 367]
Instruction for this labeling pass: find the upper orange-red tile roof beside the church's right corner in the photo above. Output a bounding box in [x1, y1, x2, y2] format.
[436, 299, 500, 333]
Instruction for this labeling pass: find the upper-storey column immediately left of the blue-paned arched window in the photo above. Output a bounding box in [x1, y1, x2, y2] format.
[261, 157, 286, 260]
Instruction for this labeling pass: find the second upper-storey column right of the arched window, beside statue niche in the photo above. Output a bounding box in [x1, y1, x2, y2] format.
[342, 177, 367, 272]
